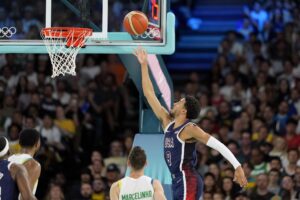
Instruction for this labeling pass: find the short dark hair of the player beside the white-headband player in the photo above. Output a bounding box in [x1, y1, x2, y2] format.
[19, 129, 40, 148]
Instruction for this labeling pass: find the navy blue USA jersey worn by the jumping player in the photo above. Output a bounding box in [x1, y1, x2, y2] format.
[164, 120, 197, 175]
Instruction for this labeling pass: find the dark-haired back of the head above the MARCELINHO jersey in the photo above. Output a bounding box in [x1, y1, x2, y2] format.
[128, 146, 147, 170]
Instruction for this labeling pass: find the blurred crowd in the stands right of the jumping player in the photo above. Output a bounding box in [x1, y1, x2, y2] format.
[192, 0, 300, 200]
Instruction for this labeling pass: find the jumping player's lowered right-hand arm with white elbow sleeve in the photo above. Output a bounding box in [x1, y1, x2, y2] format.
[187, 126, 247, 187]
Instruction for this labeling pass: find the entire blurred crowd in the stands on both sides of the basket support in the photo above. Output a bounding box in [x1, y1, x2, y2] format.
[0, 0, 300, 200]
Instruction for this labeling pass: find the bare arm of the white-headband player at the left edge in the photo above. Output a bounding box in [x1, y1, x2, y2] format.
[9, 164, 36, 200]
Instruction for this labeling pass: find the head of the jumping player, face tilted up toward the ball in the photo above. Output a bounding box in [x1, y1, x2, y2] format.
[171, 95, 200, 119]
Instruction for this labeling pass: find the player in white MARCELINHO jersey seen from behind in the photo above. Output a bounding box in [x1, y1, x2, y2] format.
[110, 146, 166, 200]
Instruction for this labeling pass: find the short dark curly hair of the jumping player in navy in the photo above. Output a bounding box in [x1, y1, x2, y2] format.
[184, 95, 200, 119]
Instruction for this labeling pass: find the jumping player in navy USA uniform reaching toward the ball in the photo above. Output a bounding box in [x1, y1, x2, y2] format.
[134, 47, 247, 200]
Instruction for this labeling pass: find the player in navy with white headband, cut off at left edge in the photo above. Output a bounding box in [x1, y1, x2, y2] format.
[0, 137, 36, 200]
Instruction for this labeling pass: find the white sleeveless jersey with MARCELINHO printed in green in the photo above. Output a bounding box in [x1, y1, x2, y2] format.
[118, 176, 154, 200]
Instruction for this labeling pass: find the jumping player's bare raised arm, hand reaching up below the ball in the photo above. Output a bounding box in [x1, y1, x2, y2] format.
[134, 47, 171, 128]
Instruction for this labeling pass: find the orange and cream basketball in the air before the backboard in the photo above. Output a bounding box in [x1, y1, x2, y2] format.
[123, 11, 148, 35]
